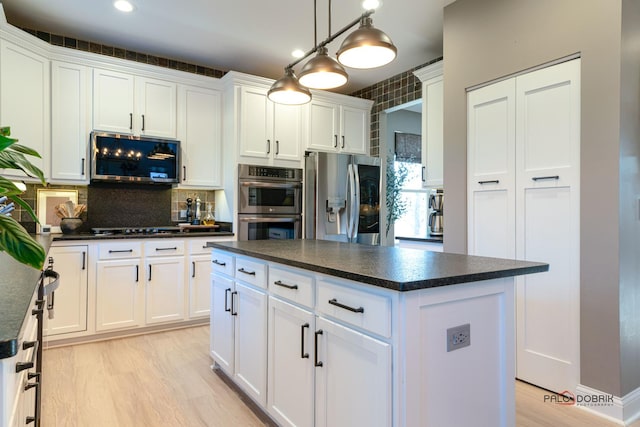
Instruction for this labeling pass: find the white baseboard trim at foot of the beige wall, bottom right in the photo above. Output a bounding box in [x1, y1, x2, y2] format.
[576, 384, 640, 426]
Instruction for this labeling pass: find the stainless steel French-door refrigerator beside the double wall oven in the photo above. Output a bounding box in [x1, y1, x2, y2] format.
[303, 153, 382, 245]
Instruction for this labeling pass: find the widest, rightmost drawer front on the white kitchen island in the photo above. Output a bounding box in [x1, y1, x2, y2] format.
[316, 279, 391, 338]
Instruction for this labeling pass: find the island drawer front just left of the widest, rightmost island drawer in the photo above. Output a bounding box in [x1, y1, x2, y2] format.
[269, 264, 314, 308]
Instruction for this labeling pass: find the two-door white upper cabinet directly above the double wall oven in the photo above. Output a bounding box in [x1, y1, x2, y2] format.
[239, 86, 302, 164]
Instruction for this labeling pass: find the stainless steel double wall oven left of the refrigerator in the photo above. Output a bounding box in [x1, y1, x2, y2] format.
[238, 165, 302, 240]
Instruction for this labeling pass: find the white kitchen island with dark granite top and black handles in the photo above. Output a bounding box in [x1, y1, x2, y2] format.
[209, 240, 548, 427]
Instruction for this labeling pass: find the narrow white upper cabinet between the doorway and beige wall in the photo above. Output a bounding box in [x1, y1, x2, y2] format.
[414, 61, 444, 188]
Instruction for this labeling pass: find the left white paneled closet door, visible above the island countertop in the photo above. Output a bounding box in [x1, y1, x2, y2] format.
[467, 79, 516, 258]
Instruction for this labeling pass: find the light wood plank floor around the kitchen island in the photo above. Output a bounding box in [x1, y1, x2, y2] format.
[42, 326, 640, 427]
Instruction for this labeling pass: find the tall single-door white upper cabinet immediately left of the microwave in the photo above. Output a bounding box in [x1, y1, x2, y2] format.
[51, 61, 91, 184]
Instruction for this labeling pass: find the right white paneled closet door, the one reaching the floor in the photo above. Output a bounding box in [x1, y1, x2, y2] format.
[516, 59, 580, 392]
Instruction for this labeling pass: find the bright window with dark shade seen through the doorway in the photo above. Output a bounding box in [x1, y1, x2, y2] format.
[394, 132, 429, 239]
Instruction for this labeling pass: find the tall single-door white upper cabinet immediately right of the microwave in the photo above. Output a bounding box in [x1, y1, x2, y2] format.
[178, 85, 222, 188]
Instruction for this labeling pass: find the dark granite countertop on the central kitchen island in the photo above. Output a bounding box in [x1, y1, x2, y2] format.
[207, 240, 549, 291]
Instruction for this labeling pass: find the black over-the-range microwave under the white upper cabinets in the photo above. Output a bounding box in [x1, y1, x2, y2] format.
[91, 132, 180, 184]
